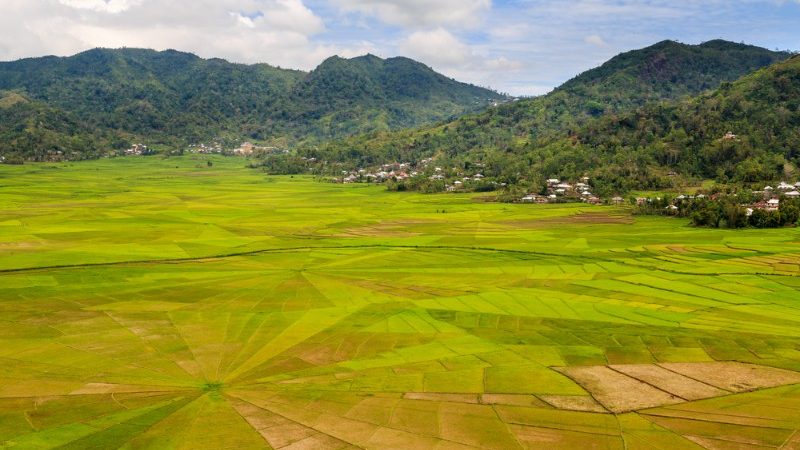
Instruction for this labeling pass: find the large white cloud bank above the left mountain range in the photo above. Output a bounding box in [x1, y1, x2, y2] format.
[0, 0, 354, 69]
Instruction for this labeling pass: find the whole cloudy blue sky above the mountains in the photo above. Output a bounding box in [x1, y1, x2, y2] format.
[0, 0, 800, 96]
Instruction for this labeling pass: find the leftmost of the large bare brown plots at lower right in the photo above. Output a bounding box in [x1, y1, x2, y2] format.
[558, 366, 683, 413]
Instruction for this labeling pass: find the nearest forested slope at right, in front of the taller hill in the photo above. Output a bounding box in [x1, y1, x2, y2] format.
[302, 46, 800, 195]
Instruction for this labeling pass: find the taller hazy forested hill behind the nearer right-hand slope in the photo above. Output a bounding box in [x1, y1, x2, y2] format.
[316, 40, 789, 169]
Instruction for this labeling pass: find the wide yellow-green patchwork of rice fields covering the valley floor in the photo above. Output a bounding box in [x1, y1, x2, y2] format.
[0, 157, 800, 449]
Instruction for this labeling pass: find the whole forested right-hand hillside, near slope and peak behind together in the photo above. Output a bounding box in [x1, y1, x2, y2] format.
[284, 41, 800, 194]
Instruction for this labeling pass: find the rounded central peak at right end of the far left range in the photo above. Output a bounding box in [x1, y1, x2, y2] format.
[292, 55, 505, 137]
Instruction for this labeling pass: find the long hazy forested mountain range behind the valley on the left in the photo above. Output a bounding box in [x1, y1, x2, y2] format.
[0, 49, 505, 159]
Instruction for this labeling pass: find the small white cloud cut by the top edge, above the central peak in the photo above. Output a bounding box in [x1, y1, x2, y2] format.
[333, 0, 492, 28]
